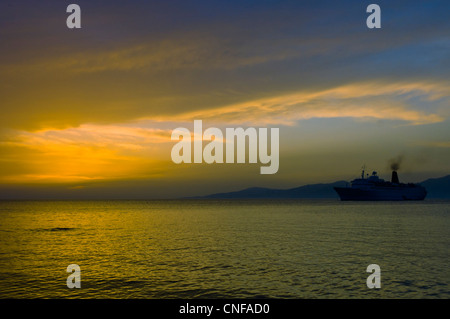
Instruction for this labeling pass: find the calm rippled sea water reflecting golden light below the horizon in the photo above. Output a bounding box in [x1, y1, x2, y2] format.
[0, 200, 450, 298]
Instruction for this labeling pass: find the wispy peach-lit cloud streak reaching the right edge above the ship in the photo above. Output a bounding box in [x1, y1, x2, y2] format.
[156, 82, 450, 125]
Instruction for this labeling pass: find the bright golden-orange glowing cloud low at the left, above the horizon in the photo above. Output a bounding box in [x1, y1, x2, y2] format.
[0, 124, 174, 183]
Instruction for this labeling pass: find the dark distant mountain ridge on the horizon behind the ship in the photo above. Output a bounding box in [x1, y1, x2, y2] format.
[196, 175, 450, 199]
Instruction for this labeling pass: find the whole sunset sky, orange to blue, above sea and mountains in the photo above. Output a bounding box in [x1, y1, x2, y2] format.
[0, 0, 450, 199]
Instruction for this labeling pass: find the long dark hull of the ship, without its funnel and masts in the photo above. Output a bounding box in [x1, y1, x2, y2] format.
[334, 186, 427, 201]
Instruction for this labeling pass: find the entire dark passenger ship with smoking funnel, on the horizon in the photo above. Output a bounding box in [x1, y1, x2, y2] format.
[334, 168, 427, 201]
